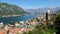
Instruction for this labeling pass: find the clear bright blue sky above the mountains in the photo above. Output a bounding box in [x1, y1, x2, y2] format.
[0, 0, 60, 9]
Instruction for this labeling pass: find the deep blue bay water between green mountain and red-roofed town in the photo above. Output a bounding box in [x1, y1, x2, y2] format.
[0, 14, 35, 24]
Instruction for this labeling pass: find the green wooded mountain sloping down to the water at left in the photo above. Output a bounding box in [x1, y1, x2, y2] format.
[0, 3, 27, 16]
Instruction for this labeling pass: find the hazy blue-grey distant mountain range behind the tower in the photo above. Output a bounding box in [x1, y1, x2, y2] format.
[25, 7, 60, 15]
